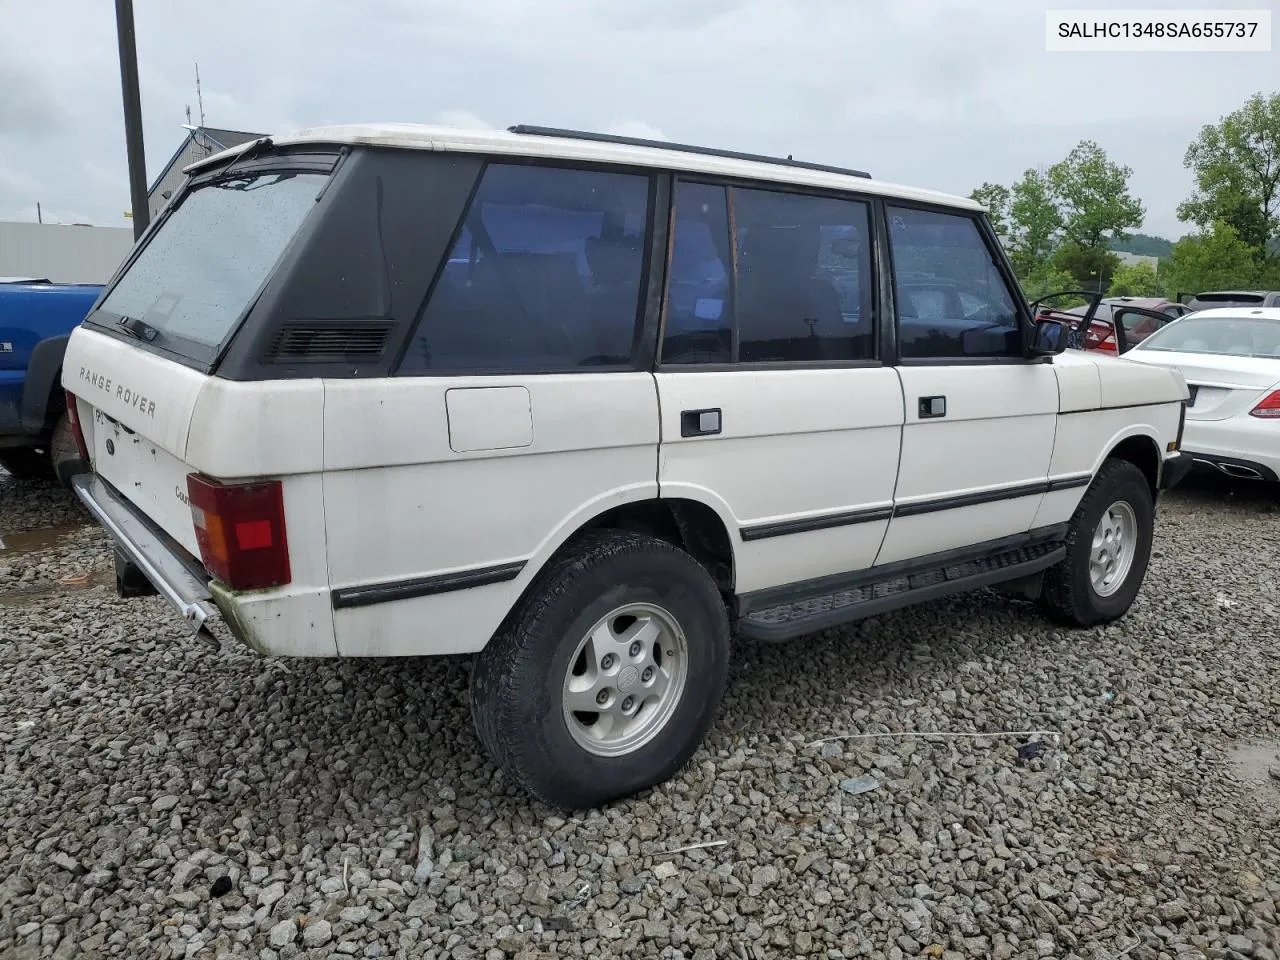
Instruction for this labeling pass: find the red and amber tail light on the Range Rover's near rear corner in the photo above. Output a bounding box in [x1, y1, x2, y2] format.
[187, 474, 291, 590]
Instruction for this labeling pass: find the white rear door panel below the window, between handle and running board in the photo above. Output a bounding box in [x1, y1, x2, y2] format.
[655, 367, 902, 593]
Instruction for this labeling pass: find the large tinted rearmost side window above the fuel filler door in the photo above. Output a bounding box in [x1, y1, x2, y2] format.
[399, 164, 650, 375]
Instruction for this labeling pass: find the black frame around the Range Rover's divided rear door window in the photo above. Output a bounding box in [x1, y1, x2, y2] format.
[653, 170, 892, 374]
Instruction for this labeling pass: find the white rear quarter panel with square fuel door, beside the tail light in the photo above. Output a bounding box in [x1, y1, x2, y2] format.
[324, 372, 658, 657]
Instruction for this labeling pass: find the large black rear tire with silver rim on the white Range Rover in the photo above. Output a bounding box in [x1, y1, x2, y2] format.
[471, 531, 730, 810]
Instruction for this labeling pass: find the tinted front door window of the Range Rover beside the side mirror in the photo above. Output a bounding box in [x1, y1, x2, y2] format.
[888, 206, 1023, 360]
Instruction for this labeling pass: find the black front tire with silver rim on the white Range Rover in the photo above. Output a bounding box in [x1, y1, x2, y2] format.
[1041, 460, 1156, 627]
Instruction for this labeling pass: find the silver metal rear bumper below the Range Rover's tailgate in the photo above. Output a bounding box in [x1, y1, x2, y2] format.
[70, 474, 220, 634]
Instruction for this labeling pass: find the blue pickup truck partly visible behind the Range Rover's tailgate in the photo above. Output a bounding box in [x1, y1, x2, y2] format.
[0, 278, 102, 483]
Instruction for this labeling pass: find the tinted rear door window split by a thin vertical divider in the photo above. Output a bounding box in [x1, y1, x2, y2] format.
[662, 182, 874, 364]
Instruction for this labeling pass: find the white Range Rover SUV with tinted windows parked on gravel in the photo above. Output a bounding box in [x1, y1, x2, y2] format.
[63, 125, 1188, 809]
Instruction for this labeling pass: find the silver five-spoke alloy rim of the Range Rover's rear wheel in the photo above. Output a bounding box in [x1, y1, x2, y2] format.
[561, 603, 689, 756]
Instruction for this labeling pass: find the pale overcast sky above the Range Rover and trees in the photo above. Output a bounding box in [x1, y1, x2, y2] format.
[0, 0, 1280, 238]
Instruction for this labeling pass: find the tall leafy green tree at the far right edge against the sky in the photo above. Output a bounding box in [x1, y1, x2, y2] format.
[1178, 92, 1280, 260]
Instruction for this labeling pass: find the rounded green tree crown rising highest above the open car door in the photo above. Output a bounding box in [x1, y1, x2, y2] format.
[1048, 140, 1146, 250]
